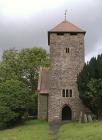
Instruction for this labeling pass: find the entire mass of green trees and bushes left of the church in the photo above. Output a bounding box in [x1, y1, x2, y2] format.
[0, 48, 49, 128]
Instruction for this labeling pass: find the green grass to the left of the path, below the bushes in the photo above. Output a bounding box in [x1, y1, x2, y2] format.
[0, 120, 48, 140]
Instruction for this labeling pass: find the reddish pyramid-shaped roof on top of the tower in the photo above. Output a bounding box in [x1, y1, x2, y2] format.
[49, 20, 85, 33]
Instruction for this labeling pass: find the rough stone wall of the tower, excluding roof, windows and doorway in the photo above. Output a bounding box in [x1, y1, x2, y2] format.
[48, 33, 84, 121]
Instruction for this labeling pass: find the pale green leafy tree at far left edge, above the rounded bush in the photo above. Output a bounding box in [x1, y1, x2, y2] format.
[0, 49, 19, 82]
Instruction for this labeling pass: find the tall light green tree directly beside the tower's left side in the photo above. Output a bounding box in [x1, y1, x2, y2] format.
[18, 48, 49, 92]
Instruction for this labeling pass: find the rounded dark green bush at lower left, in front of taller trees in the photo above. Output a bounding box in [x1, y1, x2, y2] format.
[0, 79, 32, 128]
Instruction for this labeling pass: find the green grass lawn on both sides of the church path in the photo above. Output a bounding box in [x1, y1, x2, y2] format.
[0, 120, 102, 140]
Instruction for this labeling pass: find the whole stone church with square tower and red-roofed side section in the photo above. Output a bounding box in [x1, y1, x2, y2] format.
[38, 20, 87, 122]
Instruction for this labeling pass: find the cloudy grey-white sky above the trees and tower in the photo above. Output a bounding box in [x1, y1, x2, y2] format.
[0, 0, 102, 60]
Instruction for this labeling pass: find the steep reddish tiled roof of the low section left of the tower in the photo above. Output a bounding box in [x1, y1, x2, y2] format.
[38, 67, 49, 94]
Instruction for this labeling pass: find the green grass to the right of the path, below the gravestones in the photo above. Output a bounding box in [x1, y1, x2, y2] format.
[59, 122, 102, 140]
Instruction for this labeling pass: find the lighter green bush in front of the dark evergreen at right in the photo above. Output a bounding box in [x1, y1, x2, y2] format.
[87, 79, 102, 118]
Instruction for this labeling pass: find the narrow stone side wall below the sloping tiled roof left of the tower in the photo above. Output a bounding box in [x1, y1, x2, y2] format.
[38, 94, 48, 120]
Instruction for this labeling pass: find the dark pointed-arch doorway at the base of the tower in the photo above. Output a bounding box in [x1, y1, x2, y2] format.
[62, 105, 72, 120]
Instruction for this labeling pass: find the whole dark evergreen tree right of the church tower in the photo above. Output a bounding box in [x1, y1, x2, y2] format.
[77, 55, 102, 118]
